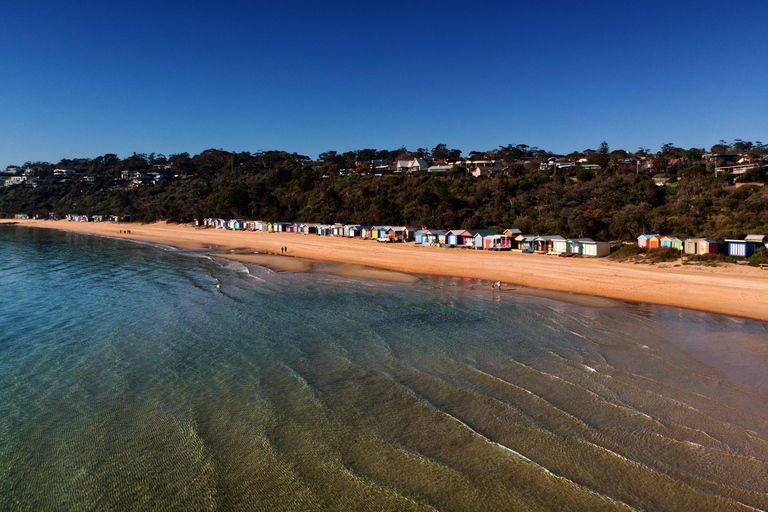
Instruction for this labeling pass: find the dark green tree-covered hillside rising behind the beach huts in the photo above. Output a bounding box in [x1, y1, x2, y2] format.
[0, 150, 768, 240]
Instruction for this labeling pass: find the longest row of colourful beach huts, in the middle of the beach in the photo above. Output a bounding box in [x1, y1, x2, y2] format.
[201, 218, 611, 257]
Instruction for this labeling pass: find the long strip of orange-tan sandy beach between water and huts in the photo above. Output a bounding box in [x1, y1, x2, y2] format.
[6, 220, 768, 321]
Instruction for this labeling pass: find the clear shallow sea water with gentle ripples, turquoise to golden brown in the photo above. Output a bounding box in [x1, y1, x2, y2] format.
[0, 226, 768, 511]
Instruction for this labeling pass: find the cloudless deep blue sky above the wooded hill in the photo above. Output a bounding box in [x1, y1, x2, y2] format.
[0, 0, 768, 168]
